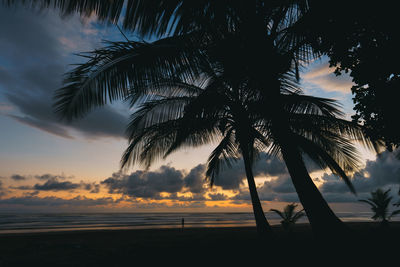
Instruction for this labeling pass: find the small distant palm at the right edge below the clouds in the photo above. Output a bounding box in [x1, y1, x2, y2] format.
[359, 188, 400, 226]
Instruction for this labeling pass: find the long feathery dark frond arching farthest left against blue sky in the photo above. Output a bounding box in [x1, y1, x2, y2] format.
[54, 37, 204, 119]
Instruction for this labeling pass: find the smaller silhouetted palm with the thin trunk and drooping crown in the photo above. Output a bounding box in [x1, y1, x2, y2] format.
[122, 73, 271, 234]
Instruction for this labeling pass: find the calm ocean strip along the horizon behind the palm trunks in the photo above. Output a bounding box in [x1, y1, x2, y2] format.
[0, 212, 378, 234]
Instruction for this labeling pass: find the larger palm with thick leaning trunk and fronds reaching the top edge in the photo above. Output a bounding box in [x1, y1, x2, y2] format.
[6, 0, 380, 239]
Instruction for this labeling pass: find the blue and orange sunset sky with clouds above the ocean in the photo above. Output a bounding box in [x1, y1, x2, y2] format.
[0, 7, 400, 216]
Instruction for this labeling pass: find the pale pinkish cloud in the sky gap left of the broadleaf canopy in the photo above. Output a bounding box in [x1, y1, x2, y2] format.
[302, 61, 353, 94]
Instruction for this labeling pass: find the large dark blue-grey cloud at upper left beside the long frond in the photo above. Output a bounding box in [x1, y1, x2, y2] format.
[0, 7, 127, 138]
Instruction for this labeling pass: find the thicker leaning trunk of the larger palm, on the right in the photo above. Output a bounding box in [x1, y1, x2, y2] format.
[281, 142, 348, 237]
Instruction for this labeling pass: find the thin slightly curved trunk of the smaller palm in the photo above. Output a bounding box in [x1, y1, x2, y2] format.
[243, 151, 272, 235]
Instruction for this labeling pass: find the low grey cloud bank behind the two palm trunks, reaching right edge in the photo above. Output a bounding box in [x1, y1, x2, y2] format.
[231, 151, 400, 203]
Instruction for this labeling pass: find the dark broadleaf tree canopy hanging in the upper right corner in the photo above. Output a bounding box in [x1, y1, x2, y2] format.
[303, 1, 400, 150]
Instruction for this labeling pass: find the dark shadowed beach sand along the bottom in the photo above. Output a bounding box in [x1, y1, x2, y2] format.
[0, 222, 400, 266]
